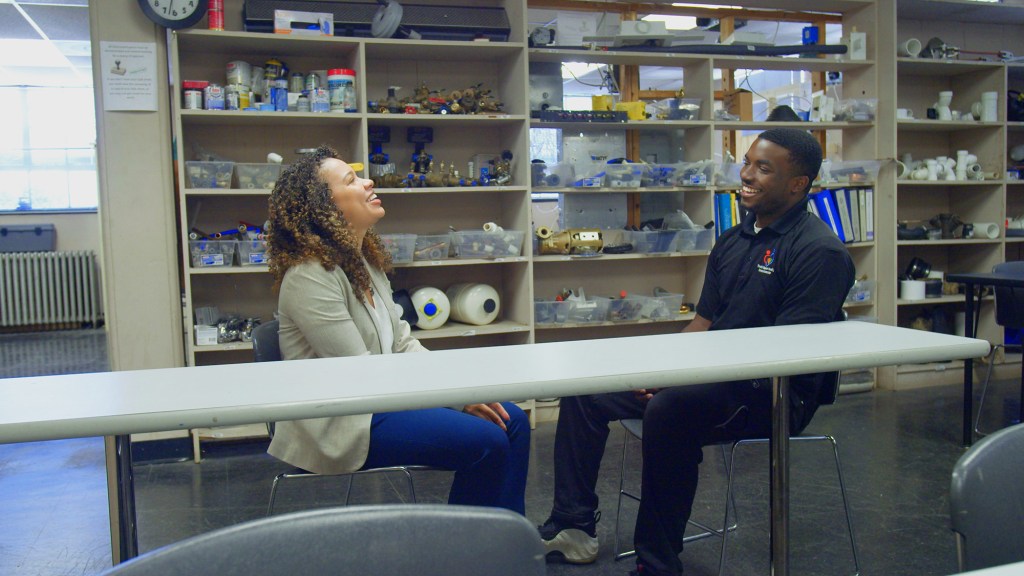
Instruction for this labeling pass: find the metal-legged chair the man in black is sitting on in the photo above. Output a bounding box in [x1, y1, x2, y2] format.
[614, 372, 860, 576]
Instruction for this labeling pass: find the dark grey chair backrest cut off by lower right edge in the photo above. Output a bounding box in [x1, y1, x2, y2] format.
[949, 424, 1024, 570]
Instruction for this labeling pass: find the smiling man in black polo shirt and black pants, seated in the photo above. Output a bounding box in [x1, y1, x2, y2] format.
[540, 128, 855, 576]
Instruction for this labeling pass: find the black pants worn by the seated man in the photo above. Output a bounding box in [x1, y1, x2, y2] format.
[551, 380, 771, 576]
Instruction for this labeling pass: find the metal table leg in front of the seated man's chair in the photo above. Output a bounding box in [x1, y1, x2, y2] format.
[769, 376, 790, 576]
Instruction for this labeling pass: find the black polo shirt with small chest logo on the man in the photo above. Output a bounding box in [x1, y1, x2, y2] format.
[697, 199, 855, 330]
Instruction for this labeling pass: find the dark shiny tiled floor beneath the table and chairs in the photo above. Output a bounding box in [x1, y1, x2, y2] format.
[0, 331, 1019, 576]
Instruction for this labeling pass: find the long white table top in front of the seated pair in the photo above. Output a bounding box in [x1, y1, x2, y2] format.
[0, 322, 989, 443]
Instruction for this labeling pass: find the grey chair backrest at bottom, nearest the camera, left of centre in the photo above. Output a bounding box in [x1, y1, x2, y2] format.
[103, 504, 546, 576]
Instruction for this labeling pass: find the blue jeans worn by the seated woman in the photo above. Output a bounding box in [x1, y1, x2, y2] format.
[362, 402, 529, 515]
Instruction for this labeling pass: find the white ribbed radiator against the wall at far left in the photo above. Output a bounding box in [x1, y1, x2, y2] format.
[0, 251, 102, 330]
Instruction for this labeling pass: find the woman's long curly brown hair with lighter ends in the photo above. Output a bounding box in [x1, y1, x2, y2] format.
[267, 146, 391, 301]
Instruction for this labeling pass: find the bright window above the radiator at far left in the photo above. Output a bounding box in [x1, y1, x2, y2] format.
[0, 86, 98, 212]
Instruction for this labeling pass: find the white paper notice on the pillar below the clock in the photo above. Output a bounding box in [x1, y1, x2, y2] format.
[99, 42, 157, 112]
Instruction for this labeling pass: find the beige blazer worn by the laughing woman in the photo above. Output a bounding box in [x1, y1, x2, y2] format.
[267, 261, 427, 474]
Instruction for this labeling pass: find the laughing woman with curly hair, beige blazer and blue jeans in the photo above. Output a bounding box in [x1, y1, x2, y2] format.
[267, 147, 529, 513]
